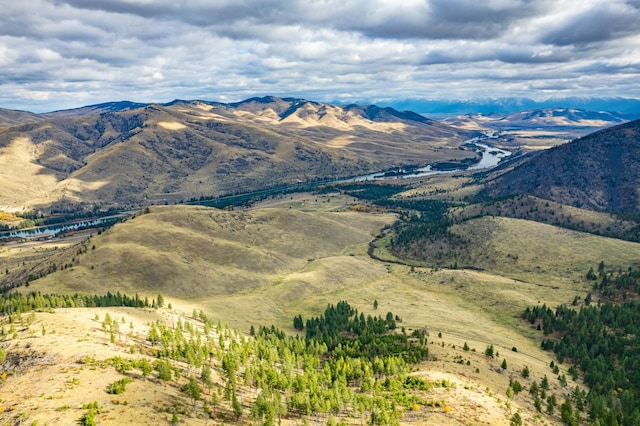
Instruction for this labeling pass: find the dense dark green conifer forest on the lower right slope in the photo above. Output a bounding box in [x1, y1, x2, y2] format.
[522, 264, 640, 426]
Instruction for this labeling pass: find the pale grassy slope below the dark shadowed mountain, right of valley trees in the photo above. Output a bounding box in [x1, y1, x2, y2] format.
[453, 217, 640, 291]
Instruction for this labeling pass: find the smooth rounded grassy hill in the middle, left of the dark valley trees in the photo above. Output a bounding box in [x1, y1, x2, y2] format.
[23, 194, 393, 324]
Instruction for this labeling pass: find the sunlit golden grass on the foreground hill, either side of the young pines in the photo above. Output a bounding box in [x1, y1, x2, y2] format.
[0, 299, 562, 425]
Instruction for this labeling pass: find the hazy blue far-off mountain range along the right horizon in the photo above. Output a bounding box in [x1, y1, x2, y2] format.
[379, 97, 640, 119]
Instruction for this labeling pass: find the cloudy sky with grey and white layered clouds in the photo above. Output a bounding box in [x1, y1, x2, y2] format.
[0, 0, 640, 112]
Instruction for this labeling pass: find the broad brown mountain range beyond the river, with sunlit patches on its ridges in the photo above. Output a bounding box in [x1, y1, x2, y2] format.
[0, 97, 474, 210]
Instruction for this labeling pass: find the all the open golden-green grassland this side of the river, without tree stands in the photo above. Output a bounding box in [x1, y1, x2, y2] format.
[0, 191, 640, 425]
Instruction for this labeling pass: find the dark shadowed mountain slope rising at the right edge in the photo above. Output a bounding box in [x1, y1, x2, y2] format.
[487, 120, 640, 212]
